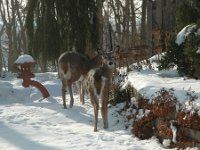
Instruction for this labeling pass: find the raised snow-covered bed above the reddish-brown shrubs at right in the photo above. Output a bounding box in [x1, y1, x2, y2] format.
[124, 55, 200, 115]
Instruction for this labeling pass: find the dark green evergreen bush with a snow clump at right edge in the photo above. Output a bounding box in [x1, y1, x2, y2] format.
[159, 24, 200, 78]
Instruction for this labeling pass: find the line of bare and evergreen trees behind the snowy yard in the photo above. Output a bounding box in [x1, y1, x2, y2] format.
[0, 0, 199, 72]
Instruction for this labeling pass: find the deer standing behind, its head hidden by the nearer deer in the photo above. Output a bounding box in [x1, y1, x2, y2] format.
[58, 52, 103, 108]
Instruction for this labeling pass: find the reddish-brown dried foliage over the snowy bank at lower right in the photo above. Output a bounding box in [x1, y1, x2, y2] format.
[132, 89, 200, 149]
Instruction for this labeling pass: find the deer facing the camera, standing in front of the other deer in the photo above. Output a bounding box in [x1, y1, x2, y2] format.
[84, 53, 115, 132]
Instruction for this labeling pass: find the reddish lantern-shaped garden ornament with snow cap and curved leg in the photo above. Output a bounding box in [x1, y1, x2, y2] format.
[15, 55, 49, 98]
